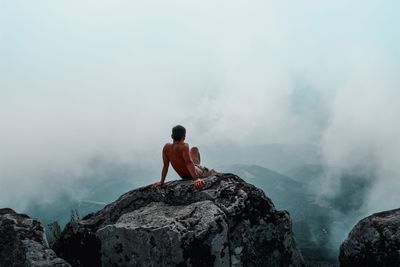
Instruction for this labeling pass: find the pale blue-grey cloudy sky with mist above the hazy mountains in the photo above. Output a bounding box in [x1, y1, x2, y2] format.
[0, 0, 400, 217]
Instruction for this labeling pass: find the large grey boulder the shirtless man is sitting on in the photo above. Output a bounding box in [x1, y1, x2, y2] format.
[53, 174, 304, 267]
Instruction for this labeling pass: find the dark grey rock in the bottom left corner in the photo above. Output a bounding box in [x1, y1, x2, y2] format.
[0, 208, 70, 267]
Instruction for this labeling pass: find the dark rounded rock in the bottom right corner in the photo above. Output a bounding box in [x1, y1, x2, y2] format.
[339, 209, 400, 267]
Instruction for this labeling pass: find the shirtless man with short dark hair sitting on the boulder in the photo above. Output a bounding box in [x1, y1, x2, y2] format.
[152, 125, 214, 189]
